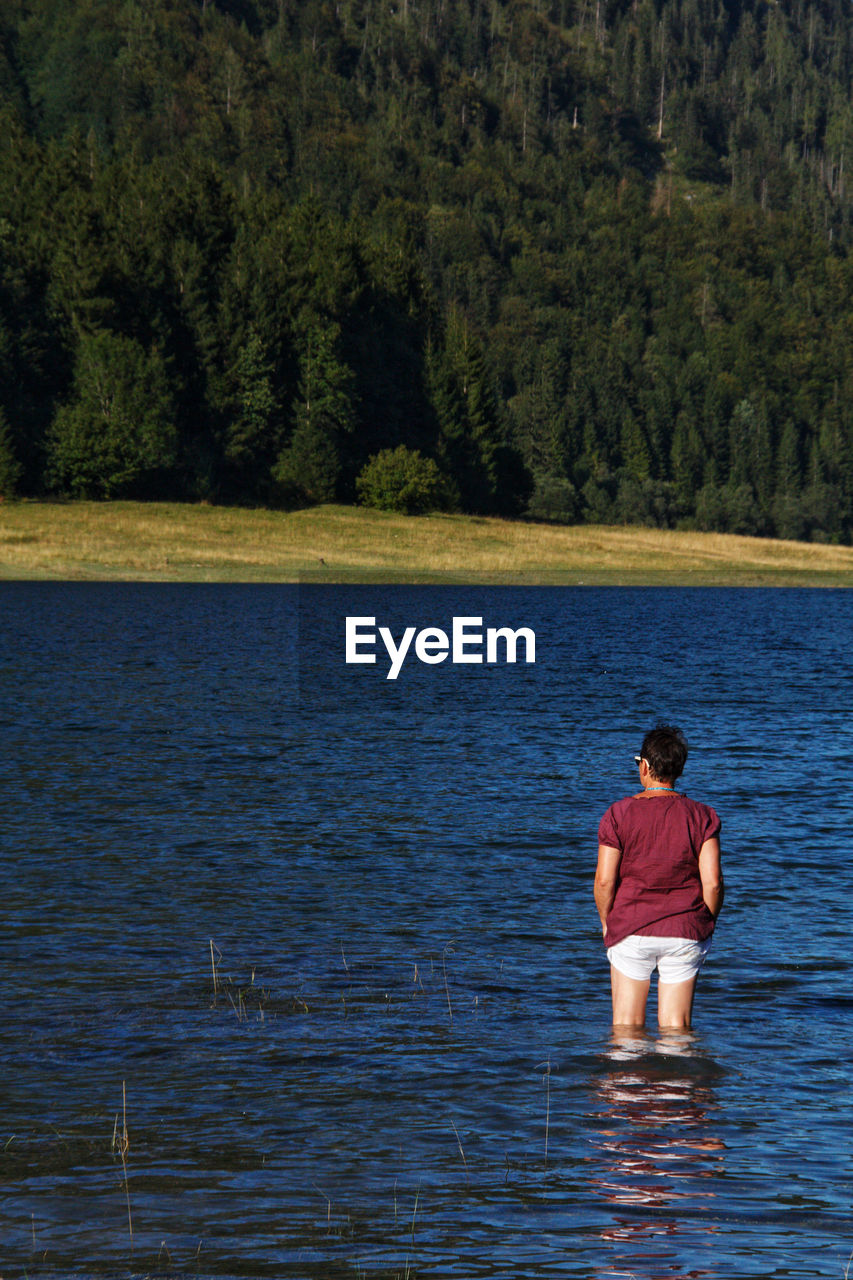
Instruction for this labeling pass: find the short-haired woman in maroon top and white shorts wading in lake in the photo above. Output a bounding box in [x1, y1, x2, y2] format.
[596, 724, 724, 1028]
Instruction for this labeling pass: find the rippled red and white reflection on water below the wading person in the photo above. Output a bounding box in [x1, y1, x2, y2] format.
[593, 1030, 725, 1280]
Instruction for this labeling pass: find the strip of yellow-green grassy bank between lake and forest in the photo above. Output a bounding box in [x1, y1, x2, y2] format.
[0, 502, 853, 586]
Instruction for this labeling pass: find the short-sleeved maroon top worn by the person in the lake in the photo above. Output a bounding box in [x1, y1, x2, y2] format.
[598, 792, 720, 947]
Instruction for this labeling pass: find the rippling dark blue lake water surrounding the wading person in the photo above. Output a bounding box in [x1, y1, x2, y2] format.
[0, 584, 853, 1280]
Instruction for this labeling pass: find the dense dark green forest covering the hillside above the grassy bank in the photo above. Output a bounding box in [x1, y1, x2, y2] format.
[0, 0, 853, 543]
